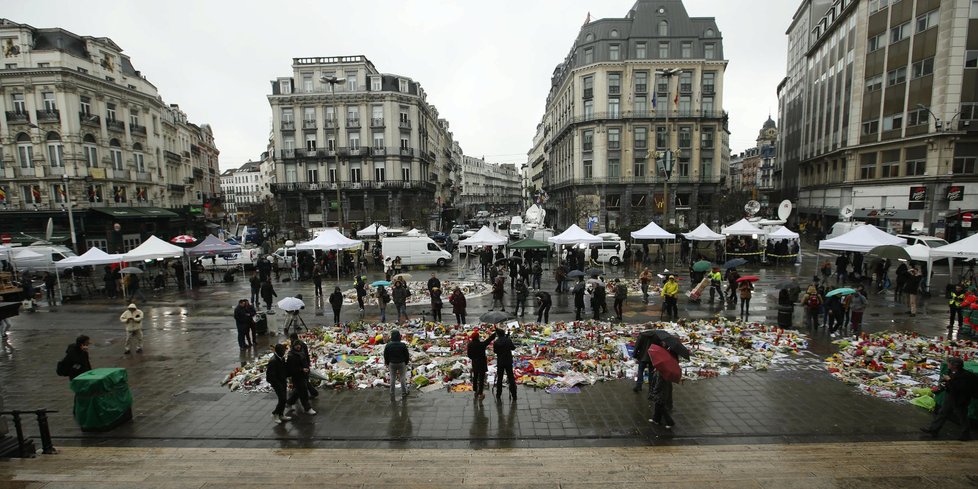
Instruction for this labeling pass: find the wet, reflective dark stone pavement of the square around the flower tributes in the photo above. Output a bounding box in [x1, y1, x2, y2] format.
[0, 248, 960, 448]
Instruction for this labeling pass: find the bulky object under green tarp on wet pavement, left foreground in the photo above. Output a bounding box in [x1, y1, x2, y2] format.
[71, 368, 132, 431]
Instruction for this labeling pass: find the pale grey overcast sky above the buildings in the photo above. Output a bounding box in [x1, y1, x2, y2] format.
[7, 0, 800, 168]
